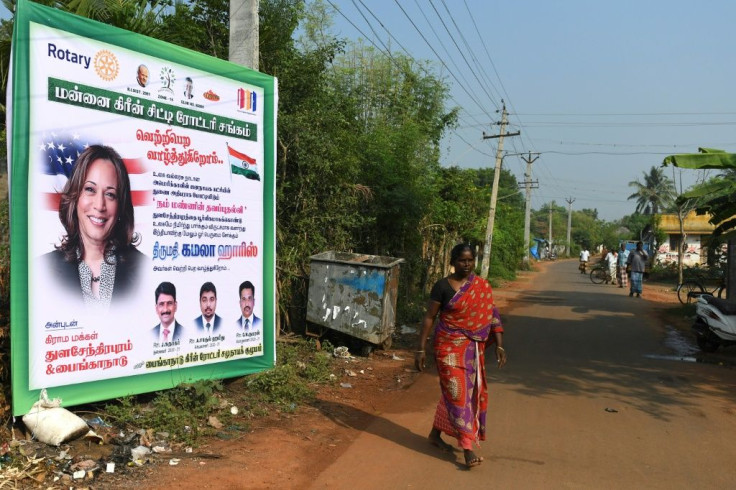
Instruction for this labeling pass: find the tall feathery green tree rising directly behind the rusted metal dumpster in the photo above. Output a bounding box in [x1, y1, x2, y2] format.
[333, 45, 454, 256]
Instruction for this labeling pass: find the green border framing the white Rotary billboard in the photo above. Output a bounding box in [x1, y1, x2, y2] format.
[8, 0, 278, 415]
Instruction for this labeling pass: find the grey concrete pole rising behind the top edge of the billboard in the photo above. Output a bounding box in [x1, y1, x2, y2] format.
[228, 0, 259, 70]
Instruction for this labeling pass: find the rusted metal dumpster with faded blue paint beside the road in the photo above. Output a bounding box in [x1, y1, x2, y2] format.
[307, 252, 404, 349]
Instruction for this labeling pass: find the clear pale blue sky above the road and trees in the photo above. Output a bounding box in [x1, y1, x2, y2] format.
[325, 0, 736, 221]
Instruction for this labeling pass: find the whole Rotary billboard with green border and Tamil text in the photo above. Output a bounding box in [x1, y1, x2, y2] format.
[8, 2, 278, 414]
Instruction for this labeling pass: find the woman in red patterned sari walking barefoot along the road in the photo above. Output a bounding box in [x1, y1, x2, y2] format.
[415, 244, 506, 468]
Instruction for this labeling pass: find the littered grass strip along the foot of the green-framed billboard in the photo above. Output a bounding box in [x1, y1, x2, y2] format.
[99, 337, 334, 446]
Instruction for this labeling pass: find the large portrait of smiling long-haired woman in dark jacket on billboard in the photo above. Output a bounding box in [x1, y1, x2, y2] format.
[46, 145, 145, 309]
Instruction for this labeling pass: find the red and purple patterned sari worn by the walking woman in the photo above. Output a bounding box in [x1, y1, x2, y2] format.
[434, 274, 503, 449]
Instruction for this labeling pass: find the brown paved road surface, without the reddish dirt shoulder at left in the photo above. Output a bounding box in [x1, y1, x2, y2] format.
[310, 261, 736, 490]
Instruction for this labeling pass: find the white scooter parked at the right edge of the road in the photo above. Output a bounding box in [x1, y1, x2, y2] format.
[692, 294, 736, 352]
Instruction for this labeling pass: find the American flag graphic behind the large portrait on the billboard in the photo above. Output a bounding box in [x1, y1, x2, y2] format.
[38, 133, 152, 211]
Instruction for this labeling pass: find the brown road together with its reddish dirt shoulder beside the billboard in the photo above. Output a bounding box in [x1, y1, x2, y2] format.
[126, 261, 736, 490]
